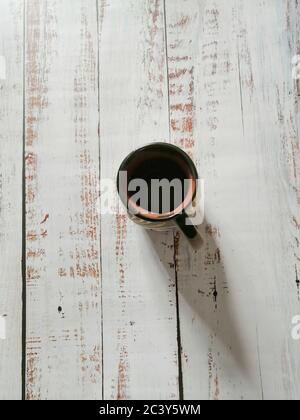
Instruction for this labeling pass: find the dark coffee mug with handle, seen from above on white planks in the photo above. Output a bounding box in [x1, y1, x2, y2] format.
[117, 143, 201, 248]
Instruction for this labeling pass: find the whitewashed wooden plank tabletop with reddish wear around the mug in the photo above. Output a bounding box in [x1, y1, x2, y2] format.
[0, 0, 300, 399]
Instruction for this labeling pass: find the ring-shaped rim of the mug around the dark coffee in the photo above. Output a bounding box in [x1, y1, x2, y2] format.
[117, 142, 199, 223]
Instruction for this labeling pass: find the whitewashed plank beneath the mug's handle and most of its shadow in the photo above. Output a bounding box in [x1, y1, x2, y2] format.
[166, 0, 261, 399]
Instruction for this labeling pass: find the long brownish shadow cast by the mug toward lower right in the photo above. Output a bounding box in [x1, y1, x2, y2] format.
[145, 220, 255, 383]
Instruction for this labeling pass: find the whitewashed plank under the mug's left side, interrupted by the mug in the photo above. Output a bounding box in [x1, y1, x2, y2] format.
[99, 0, 179, 399]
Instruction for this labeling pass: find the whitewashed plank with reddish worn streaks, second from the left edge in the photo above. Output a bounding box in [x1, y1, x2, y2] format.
[25, 0, 102, 399]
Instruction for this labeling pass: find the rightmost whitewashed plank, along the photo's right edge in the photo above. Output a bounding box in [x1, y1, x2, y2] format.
[237, 0, 300, 400]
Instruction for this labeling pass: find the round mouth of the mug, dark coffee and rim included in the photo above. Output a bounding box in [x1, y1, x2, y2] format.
[117, 143, 198, 221]
